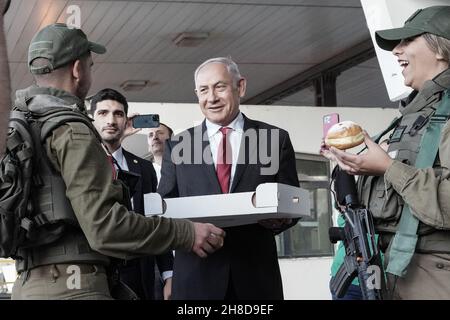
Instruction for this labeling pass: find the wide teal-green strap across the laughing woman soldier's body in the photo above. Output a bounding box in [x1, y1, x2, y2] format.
[386, 90, 450, 277]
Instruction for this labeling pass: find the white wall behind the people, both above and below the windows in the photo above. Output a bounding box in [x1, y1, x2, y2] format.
[124, 103, 398, 300]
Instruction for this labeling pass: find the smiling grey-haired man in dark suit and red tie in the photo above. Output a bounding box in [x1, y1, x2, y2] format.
[158, 58, 299, 300]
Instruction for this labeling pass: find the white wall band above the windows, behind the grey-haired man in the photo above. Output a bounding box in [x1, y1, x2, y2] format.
[124, 103, 398, 155]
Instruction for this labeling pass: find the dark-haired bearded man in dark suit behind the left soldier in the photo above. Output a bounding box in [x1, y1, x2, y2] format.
[91, 89, 173, 300]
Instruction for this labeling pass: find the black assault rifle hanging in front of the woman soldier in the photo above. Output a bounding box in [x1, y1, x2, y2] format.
[329, 167, 385, 300]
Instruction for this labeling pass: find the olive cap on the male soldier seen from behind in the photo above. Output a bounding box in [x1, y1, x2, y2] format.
[28, 23, 106, 74]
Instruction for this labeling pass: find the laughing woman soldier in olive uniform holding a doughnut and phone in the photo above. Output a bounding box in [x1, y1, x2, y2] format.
[322, 6, 450, 299]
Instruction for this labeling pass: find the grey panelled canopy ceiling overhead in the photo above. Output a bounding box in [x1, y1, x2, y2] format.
[5, 0, 395, 107]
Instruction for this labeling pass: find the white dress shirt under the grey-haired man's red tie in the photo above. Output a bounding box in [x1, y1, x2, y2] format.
[206, 112, 244, 188]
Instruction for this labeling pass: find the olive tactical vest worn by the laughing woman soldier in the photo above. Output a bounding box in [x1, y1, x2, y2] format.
[357, 91, 450, 253]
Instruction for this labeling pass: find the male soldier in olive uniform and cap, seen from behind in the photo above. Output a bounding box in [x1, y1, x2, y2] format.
[13, 24, 224, 299]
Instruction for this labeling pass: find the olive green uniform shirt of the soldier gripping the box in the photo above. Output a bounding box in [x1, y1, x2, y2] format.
[20, 87, 194, 259]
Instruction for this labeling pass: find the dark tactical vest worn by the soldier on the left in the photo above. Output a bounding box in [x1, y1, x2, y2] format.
[15, 95, 109, 272]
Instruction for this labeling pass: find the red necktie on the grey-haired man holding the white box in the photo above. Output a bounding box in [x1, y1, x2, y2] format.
[217, 127, 232, 193]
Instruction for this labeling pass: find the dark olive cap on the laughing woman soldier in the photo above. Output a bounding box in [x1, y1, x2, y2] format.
[375, 6, 450, 51]
